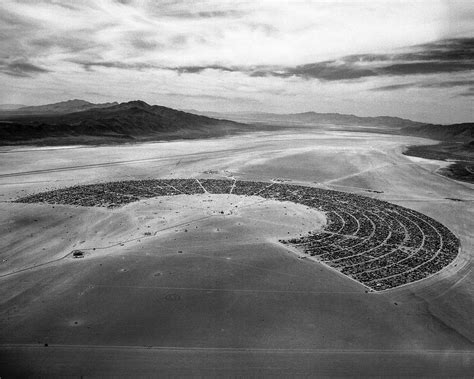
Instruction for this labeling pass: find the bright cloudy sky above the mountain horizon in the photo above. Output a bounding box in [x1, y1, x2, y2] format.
[0, 0, 474, 123]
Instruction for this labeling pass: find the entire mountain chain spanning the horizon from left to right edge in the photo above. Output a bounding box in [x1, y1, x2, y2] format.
[0, 99, 474, 145]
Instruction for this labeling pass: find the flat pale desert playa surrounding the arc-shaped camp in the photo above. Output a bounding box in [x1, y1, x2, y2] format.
[0, 130, 474, 376]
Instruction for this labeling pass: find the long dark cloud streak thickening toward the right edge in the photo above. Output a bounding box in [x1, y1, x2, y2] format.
[68, 38, 474, 85]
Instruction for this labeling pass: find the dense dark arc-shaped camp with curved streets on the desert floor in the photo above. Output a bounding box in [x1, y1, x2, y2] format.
[17, 179, 459, 291]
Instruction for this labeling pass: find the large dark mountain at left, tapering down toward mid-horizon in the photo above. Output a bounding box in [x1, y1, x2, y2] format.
[0, 100, 245, 145]
